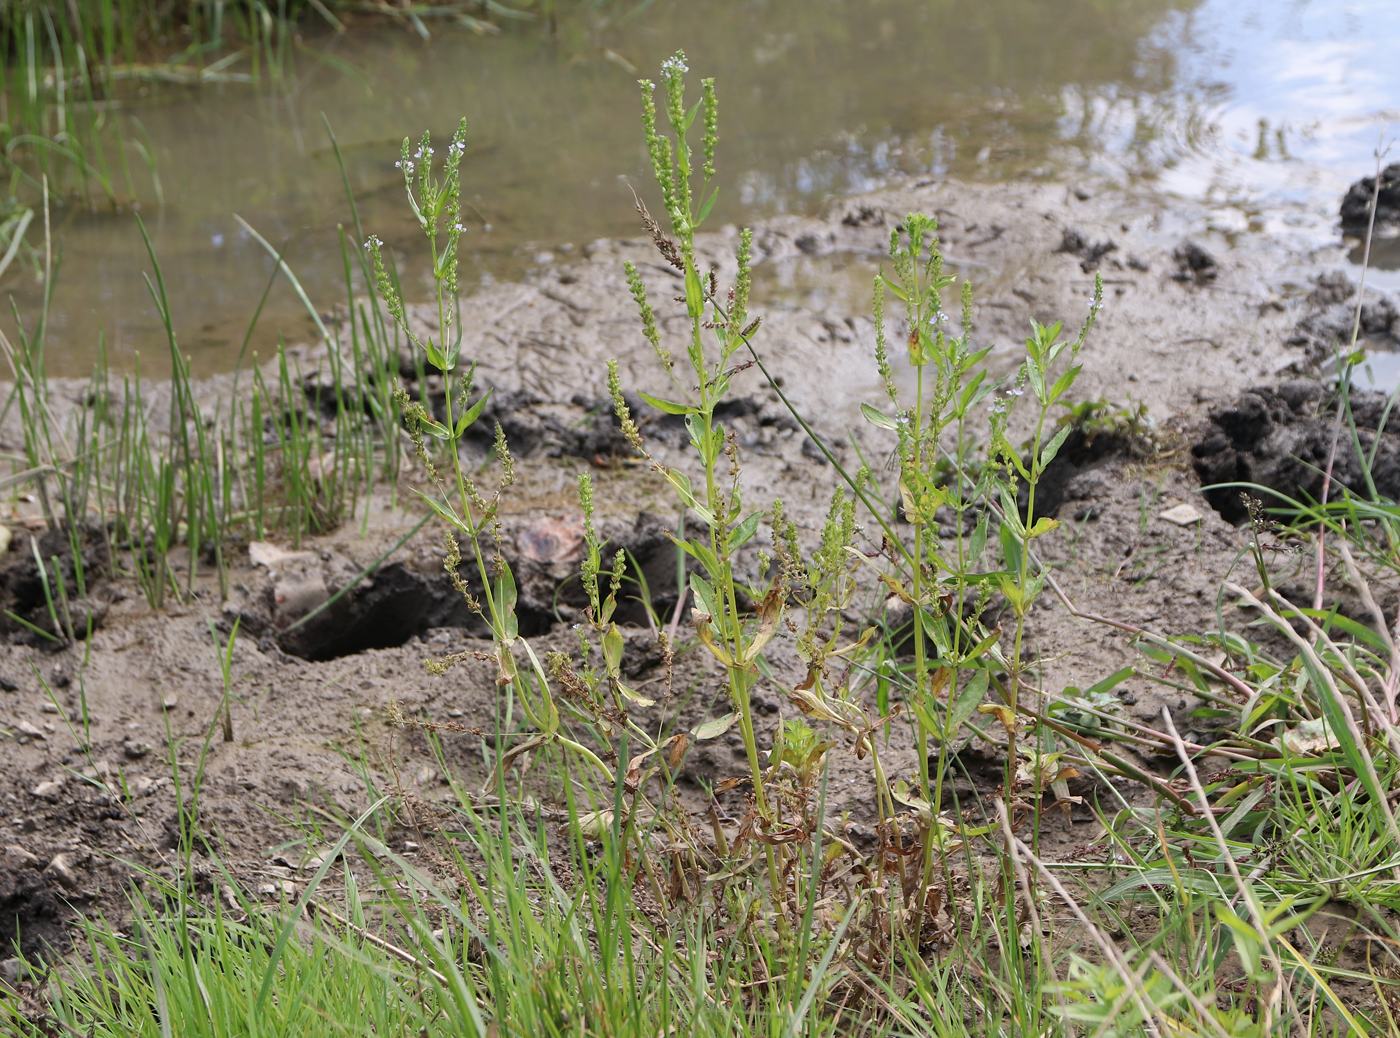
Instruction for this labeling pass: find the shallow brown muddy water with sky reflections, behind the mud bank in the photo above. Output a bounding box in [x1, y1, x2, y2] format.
[0, 0, 1400, 374]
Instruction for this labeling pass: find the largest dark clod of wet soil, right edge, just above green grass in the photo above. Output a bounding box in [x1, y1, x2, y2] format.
[1191, 380, 1400, 523]
